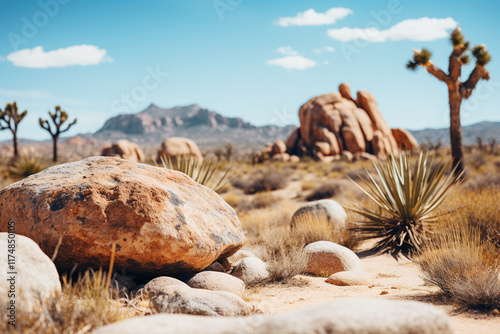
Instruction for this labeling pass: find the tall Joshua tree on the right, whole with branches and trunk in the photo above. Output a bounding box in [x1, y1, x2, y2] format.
[406, 27, 491, 173]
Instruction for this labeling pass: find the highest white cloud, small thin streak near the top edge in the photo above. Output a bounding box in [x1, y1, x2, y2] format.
[274, 7, 353, 27]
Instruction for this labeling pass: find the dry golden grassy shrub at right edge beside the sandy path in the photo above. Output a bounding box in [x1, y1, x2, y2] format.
[417, 219, 500, 311]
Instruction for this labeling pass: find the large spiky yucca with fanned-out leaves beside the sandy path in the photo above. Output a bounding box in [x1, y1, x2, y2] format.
[351, 152, 462, 259]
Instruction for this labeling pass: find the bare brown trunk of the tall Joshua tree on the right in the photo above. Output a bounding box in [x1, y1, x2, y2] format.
[449, 85, 464, 173]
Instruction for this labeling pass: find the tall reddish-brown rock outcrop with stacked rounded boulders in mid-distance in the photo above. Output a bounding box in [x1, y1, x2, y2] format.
[280, 83, 418, 160]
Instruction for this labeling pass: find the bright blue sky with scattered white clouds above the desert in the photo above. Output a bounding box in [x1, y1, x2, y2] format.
[0, 0, 500, 140]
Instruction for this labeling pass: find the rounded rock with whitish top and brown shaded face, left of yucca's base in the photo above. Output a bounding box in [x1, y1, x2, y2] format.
[304, 241, 363, 277]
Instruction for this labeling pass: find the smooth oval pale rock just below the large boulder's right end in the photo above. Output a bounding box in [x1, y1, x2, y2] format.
[187, 271, 245, 297]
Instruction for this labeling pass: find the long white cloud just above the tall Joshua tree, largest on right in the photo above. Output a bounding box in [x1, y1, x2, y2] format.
[327, 17, 458, 42]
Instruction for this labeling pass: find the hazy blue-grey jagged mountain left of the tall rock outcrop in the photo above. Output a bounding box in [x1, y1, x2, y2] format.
[92, 104, 295, 148]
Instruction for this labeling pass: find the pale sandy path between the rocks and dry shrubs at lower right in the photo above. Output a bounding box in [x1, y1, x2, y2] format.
[247, 249, 500, 334]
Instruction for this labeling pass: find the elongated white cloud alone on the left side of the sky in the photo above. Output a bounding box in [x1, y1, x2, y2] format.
[7, 44, 113, 68]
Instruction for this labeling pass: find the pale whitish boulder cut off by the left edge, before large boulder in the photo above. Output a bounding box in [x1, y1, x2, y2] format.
[0, 232, 61, 310]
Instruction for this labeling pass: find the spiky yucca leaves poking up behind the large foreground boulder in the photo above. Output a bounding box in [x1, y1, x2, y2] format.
[160, 154, 231, 192]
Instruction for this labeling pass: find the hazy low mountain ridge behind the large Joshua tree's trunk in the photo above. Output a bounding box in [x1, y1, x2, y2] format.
[410, 122, 500, 145]
